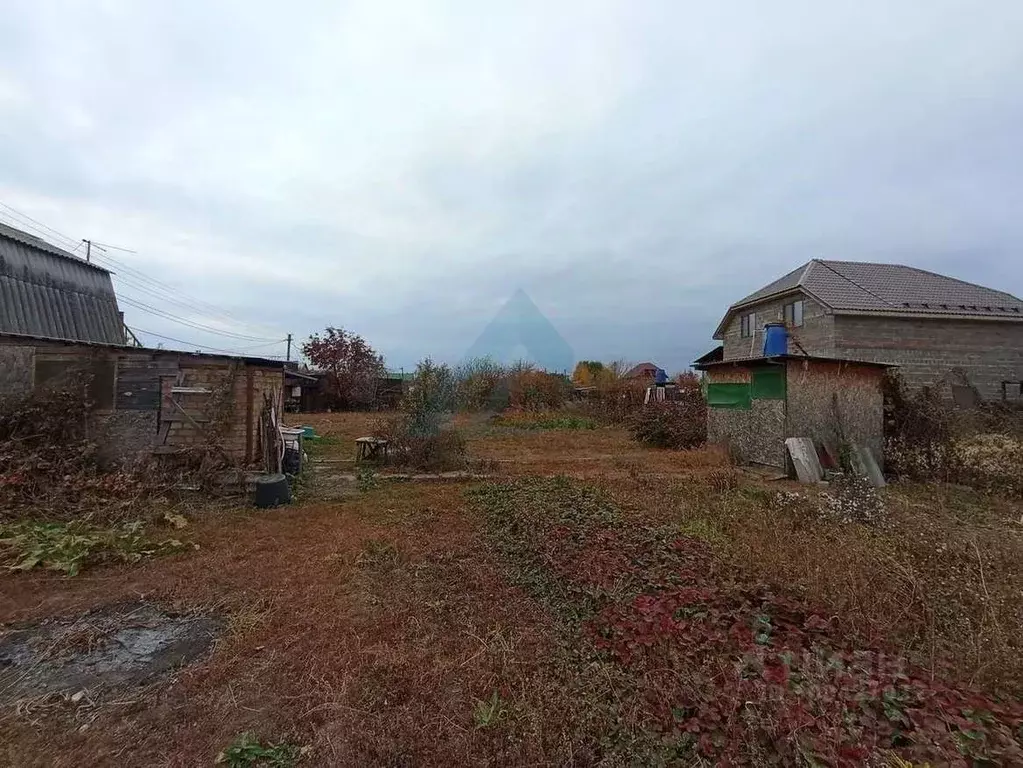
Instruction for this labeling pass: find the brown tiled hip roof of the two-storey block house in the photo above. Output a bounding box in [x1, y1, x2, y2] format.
[714, 259, 1023, 338]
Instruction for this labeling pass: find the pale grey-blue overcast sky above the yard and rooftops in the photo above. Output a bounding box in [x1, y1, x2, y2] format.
[0, 0, 1023, 369]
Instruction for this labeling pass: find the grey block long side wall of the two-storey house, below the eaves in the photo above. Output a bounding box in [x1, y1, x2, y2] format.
[835, 315, 1023, 400]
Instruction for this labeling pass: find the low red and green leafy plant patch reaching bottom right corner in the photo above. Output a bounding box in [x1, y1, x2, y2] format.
[471, 479, 1023, 765]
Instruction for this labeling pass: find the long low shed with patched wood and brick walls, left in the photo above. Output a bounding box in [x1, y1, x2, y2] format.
[0, 334, 284, 466]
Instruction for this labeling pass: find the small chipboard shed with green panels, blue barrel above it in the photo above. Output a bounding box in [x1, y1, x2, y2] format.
[695, 355, 889, 469]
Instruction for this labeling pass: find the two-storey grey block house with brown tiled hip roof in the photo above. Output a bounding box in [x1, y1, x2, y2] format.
[714, 259, 1023, 400]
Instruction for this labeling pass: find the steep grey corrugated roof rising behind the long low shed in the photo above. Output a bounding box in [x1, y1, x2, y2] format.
[0, 224, 125, 344]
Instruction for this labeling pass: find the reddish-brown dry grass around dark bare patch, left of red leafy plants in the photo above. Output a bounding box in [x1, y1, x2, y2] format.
[0, 485, 574, 766]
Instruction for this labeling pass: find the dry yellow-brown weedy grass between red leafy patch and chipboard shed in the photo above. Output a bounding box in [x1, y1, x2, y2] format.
[604, 468, 1023, 695]
